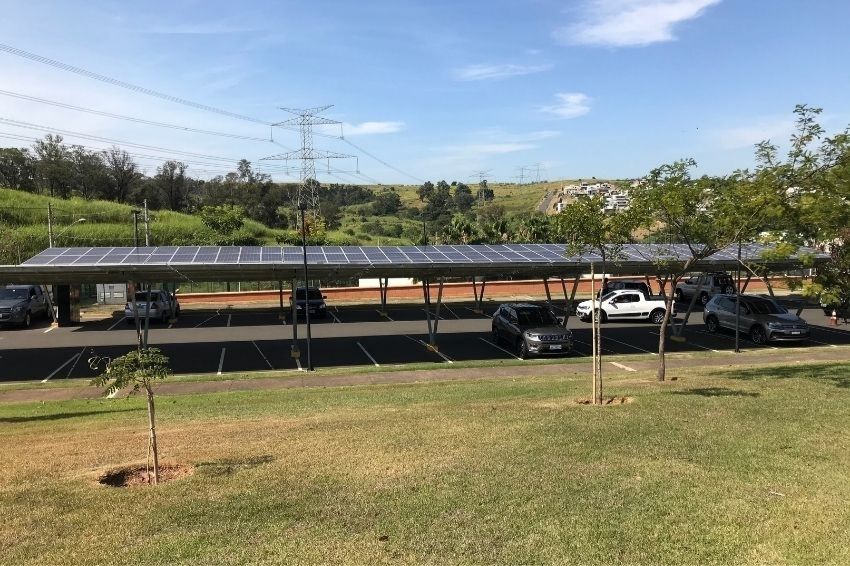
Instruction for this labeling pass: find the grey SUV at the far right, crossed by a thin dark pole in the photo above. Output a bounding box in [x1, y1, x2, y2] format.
[702, 295, 810, 344]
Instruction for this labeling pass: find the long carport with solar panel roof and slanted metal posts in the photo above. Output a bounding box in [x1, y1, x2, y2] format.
[0, 244, 829, 360]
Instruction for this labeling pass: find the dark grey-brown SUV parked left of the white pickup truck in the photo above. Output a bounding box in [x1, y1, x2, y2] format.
[492, 303, 573, 359]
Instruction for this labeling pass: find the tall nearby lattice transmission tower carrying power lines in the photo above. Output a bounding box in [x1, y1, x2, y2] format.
[261, 104, 354, 218]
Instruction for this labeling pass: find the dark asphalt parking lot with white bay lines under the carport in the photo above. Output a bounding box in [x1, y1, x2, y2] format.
[0, 303, 850, 381]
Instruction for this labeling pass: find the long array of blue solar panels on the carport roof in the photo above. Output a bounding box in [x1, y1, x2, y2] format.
[22, 244, 815, 267]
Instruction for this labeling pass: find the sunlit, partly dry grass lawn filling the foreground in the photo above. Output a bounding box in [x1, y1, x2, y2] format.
[0, 364, 850, 564]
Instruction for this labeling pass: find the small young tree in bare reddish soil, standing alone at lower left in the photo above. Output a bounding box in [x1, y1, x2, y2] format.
[90, 348, 171, 484]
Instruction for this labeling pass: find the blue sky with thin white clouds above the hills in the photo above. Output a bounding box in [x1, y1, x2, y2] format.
[0, 0, 850, 183]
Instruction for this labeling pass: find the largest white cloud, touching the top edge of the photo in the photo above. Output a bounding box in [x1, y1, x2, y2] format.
[554, 0, 721, 47]
